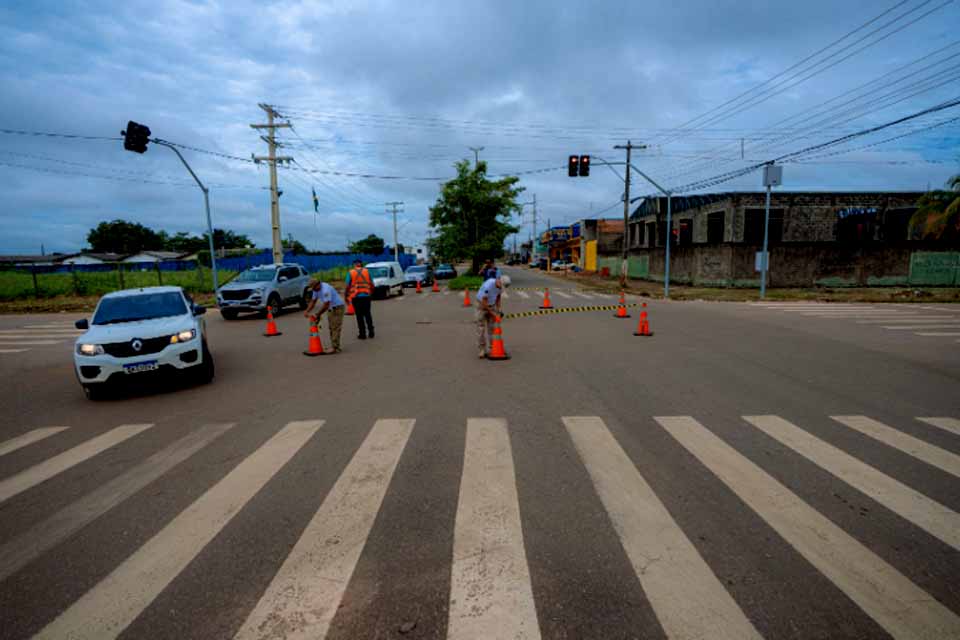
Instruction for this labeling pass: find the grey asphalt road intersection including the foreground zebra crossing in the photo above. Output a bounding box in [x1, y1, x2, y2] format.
[0, 268, 960, 640]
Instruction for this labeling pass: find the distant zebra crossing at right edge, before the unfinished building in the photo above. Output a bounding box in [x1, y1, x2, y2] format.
[750, 302, 960, 338]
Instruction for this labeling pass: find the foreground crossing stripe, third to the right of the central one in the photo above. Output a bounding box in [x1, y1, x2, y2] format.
[743, 416, 960, 549]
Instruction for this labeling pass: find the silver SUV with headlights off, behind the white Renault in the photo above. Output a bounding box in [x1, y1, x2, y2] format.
[217, 264, 310, 320]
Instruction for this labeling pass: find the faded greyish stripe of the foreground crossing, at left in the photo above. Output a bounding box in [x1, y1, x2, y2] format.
[0, 423, 233, 582]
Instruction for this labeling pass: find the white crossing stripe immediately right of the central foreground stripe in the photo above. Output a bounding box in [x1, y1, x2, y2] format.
[563, 417, 761, 640]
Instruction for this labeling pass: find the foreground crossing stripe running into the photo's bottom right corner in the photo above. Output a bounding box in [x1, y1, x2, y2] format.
[654, 416, 960, 639]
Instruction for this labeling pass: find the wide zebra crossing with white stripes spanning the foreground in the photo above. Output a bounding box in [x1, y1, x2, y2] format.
[0, 415, 960, 640]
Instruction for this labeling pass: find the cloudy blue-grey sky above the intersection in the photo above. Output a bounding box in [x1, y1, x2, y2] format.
[0, 0, 960, 253]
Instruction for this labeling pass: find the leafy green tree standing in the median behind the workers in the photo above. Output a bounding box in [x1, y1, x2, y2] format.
[430, 160, 524, 273]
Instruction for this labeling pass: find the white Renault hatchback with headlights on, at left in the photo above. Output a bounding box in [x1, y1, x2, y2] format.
[73, 287, 214, 400]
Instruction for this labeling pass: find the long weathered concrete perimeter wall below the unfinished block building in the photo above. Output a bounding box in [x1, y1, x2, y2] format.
[624, 243, 960, 287]
